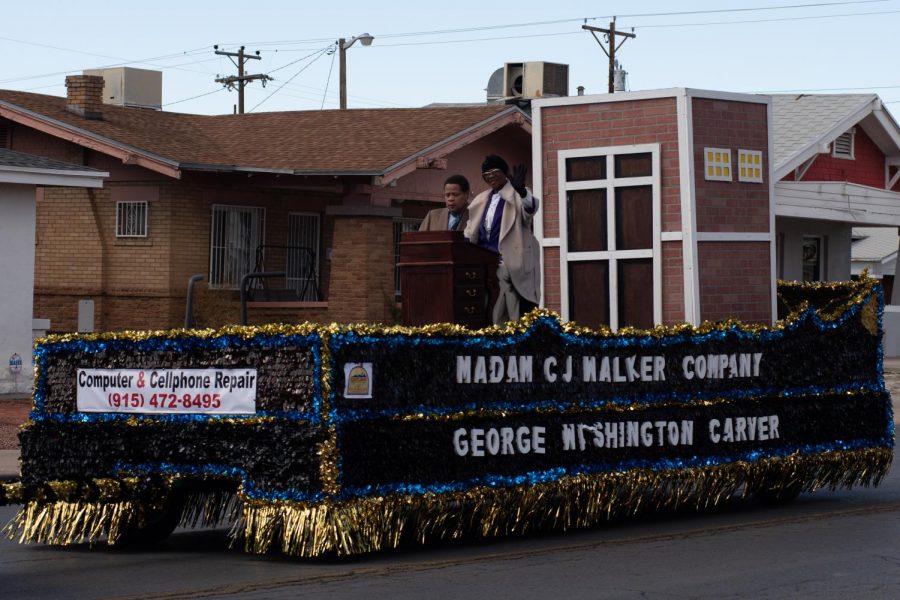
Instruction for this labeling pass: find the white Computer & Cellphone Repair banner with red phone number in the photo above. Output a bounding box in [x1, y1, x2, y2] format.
[76, 369, 257, 415]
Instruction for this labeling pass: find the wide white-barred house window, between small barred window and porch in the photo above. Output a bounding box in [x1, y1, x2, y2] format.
[209, 205, 266, 290]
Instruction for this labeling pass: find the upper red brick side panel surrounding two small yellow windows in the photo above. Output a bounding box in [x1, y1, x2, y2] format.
[691, 98, 769, 232]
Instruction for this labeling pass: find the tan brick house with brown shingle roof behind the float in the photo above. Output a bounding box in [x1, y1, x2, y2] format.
[0, 75, 531, 331]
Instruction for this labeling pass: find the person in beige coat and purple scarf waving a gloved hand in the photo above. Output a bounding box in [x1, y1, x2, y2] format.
[465, 154, 541, 325]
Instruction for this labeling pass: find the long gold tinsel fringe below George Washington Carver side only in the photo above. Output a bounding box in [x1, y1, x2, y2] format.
[232, 449, 892, 557]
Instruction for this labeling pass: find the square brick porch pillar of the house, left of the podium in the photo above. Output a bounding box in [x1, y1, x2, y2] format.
[328, 206, 400, 323]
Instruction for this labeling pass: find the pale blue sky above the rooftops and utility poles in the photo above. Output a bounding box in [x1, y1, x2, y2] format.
[0, 0, 900, 115]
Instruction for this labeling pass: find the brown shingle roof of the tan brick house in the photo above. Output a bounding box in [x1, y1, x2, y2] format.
[0, 90, 518, 173]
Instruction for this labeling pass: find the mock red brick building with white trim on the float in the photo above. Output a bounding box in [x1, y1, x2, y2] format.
[533, 89, 775, 330]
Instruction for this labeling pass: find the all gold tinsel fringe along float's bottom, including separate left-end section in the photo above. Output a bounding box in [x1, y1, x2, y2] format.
[3, 448, 893, 557]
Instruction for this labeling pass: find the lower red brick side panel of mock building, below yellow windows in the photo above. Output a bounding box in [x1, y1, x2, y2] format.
[697, 242, 772, 323]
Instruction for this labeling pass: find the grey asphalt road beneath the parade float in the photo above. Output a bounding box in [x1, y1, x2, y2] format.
[0, 469, 900, 600]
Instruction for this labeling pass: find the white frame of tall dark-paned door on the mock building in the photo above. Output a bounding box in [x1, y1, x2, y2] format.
[557, 144, 662, 331]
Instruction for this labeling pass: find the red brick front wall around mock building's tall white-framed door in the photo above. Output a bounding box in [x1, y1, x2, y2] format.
[540, 97, 684, 323]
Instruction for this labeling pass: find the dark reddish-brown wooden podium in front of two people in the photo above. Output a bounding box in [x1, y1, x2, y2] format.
[398, 231, 499, 329]
